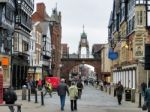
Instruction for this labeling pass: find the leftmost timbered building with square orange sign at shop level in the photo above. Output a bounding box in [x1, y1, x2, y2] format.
[0, 0, 16, 88]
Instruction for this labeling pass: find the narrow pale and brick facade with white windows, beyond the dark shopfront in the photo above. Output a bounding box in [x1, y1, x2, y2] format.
[28, 22, 43, 80]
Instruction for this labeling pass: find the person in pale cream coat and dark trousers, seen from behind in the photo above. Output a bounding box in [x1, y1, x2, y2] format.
[69, 82, 78, 111]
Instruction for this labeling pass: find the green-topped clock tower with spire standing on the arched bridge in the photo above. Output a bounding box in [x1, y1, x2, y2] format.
[78, 25, 89, 58]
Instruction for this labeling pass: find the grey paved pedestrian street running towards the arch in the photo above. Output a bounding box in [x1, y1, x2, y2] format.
[0, 86, 142, 112]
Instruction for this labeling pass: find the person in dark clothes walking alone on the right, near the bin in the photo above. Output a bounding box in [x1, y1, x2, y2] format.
[116, 81, 123, 105]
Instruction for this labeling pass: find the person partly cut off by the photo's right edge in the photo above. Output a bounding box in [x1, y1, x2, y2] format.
[144, 87, 150, 112]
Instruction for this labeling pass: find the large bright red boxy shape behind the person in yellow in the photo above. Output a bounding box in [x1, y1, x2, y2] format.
[45, 77, 60, 89]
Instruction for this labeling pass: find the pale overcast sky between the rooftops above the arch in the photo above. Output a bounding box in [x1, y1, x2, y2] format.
[35, 0, 113, 53]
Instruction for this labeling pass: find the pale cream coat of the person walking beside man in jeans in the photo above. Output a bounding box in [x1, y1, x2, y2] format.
[69, 85, 78, 100]
